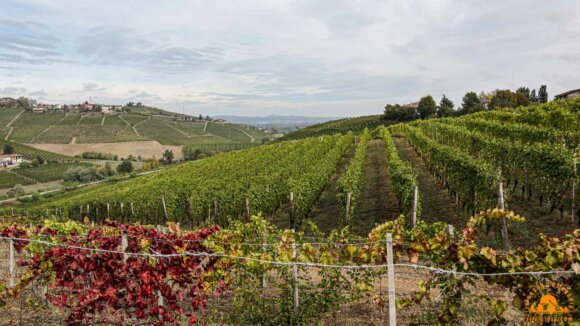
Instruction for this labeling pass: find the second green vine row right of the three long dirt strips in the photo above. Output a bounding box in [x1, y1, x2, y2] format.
[415, 122, 575, 206]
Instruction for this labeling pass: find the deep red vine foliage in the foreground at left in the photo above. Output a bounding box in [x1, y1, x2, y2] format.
[1, 221, 227, 325]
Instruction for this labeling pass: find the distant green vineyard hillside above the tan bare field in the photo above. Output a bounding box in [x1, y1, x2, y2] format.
[0, 107, 271, 146]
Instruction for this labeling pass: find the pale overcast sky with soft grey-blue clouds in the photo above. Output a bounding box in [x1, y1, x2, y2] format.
[0, 0, 580, 116]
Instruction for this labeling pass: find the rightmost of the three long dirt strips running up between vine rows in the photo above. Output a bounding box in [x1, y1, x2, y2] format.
[394, 138, 467, 228]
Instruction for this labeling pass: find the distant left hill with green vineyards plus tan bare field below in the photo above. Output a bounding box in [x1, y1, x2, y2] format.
[0, 107, 273, 158]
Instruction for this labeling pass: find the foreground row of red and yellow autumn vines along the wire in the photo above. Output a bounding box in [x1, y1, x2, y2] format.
[0, 209, 580, 326]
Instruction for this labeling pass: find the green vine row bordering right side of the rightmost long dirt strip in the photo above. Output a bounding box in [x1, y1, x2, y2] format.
[392, 124, 499, 209]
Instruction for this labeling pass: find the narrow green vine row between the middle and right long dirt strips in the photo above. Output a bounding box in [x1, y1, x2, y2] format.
[377, 127, 421, 223]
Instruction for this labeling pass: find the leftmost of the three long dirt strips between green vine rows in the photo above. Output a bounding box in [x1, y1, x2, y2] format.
[308, 145, 355, 233]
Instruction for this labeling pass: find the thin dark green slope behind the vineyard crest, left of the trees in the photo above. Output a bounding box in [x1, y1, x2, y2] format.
[277, 115, 390, 141]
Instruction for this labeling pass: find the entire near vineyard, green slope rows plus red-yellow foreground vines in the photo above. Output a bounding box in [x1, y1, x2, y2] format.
[0, 100, 580, 325]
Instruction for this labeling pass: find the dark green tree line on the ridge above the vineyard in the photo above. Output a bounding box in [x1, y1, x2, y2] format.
[383, 85, 548, 122]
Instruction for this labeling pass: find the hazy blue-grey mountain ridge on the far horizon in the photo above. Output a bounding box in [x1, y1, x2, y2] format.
[214, 114, 340, 126]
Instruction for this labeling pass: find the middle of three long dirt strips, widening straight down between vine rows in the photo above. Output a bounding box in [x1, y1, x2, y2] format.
[352, 139, 399, 236]
